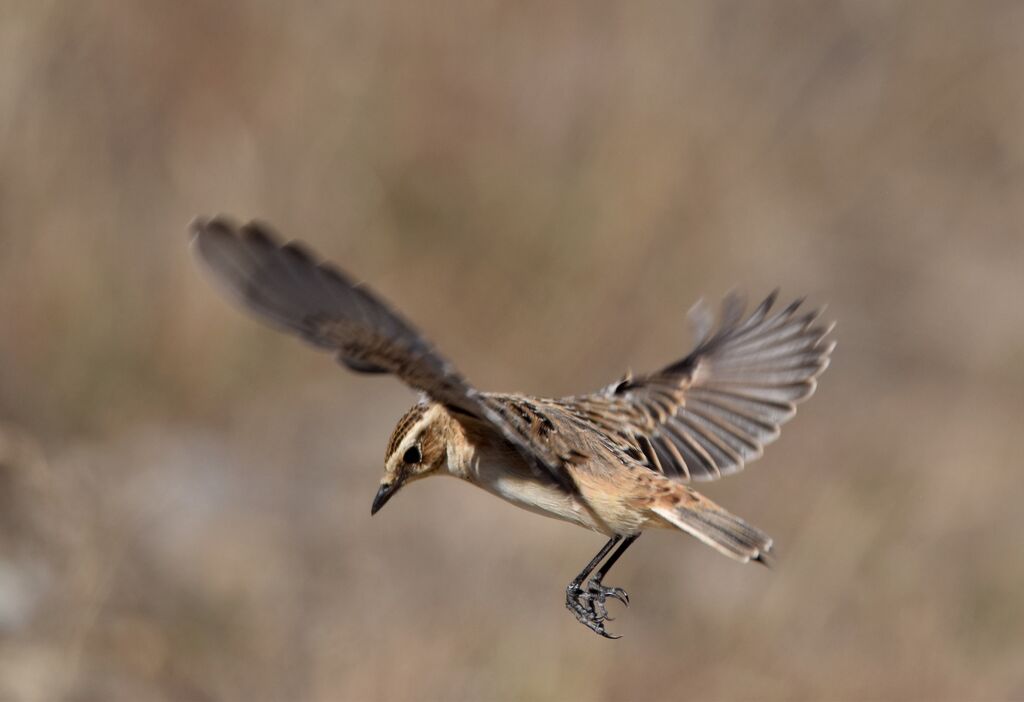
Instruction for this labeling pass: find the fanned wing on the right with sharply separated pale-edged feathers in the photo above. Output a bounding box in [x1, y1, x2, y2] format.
[564, 291, 836, 481]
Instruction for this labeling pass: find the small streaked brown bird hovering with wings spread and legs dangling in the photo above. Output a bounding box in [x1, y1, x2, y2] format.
[189, 216, 836, 639]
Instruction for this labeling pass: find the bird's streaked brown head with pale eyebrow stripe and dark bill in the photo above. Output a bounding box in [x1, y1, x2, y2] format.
[370, 402, 452, 515]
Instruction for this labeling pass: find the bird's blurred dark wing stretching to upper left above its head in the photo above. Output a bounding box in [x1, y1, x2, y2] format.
[191, 218, 580, 495]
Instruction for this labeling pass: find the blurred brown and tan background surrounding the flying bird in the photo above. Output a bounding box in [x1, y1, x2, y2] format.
[0, 0, 1024, 702]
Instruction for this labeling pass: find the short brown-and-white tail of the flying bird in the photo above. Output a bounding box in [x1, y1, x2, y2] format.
[651, 493, 772, 565]
